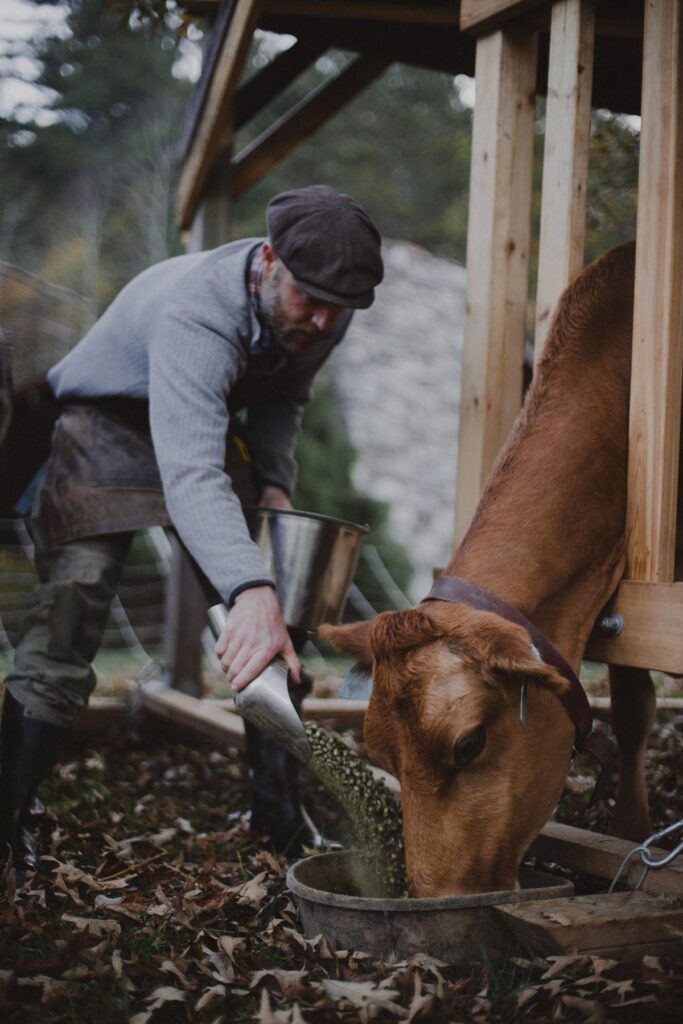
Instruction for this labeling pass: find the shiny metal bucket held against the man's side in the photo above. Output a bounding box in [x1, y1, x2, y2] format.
[245, 508, 368, 630]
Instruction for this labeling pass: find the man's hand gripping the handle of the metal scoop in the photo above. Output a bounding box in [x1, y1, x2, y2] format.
[216, 587, 301, 690]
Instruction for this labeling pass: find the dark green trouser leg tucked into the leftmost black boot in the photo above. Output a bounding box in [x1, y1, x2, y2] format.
[5, 534, 133, 726]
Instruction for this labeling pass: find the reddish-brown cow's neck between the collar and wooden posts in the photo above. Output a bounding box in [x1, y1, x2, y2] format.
[445, 288, 630, 667]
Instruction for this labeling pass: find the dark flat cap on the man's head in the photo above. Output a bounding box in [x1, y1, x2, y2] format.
[265, 185, 384, 309]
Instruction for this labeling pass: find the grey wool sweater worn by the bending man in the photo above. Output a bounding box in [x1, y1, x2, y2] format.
[48, 239, 350, 605]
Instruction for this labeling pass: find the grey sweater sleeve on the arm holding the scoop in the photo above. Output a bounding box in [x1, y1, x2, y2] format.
[150, 310, 272, 606]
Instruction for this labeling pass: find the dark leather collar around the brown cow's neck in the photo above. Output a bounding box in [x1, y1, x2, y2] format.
[425, 575, 602, 760]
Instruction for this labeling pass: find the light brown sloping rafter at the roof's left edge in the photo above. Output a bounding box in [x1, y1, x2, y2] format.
[178, 0, 263, 228]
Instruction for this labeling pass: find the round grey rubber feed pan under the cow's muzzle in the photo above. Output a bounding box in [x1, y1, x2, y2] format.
[287, 850, 573, 964]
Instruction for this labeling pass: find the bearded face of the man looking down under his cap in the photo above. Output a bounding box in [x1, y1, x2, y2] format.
[261, 250, 343, 352]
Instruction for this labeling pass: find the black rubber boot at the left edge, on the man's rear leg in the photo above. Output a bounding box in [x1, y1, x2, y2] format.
[0, 690, 70, 880]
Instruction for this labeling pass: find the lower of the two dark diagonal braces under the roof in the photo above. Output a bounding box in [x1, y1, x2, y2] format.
[230, 56, 389, 200]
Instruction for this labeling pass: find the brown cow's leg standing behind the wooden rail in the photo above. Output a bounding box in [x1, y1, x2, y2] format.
[609, 666, 655, 842]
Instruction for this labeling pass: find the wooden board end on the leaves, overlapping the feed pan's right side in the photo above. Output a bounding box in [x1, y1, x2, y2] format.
[495, 892, 683, 961]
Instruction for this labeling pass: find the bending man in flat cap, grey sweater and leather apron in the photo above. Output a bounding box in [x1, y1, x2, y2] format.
[0, 185, 383, 869]
